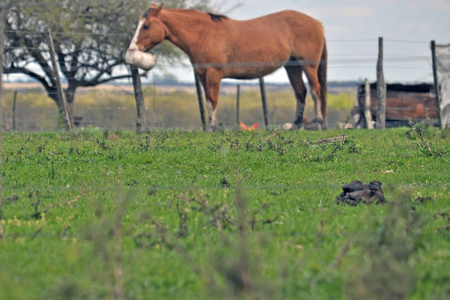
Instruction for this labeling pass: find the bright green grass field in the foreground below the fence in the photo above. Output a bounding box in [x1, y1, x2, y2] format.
[0, 124, 450, 299]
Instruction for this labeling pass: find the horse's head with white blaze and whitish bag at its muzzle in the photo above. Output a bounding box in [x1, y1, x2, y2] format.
[125, 4, 166, 70]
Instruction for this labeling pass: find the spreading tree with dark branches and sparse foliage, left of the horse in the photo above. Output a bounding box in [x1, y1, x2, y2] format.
[3, 0, 209, 126]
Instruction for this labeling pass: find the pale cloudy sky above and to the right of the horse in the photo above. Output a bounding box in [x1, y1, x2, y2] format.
[168, 0, 450, 83]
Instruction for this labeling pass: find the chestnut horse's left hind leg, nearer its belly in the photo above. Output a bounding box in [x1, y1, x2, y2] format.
[285, 66, 307, 129]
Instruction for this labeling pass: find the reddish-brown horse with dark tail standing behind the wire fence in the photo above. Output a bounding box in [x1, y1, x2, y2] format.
[126, 4, 327, 129]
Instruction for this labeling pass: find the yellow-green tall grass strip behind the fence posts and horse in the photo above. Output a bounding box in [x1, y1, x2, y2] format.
[2, 86, 354, 131]
